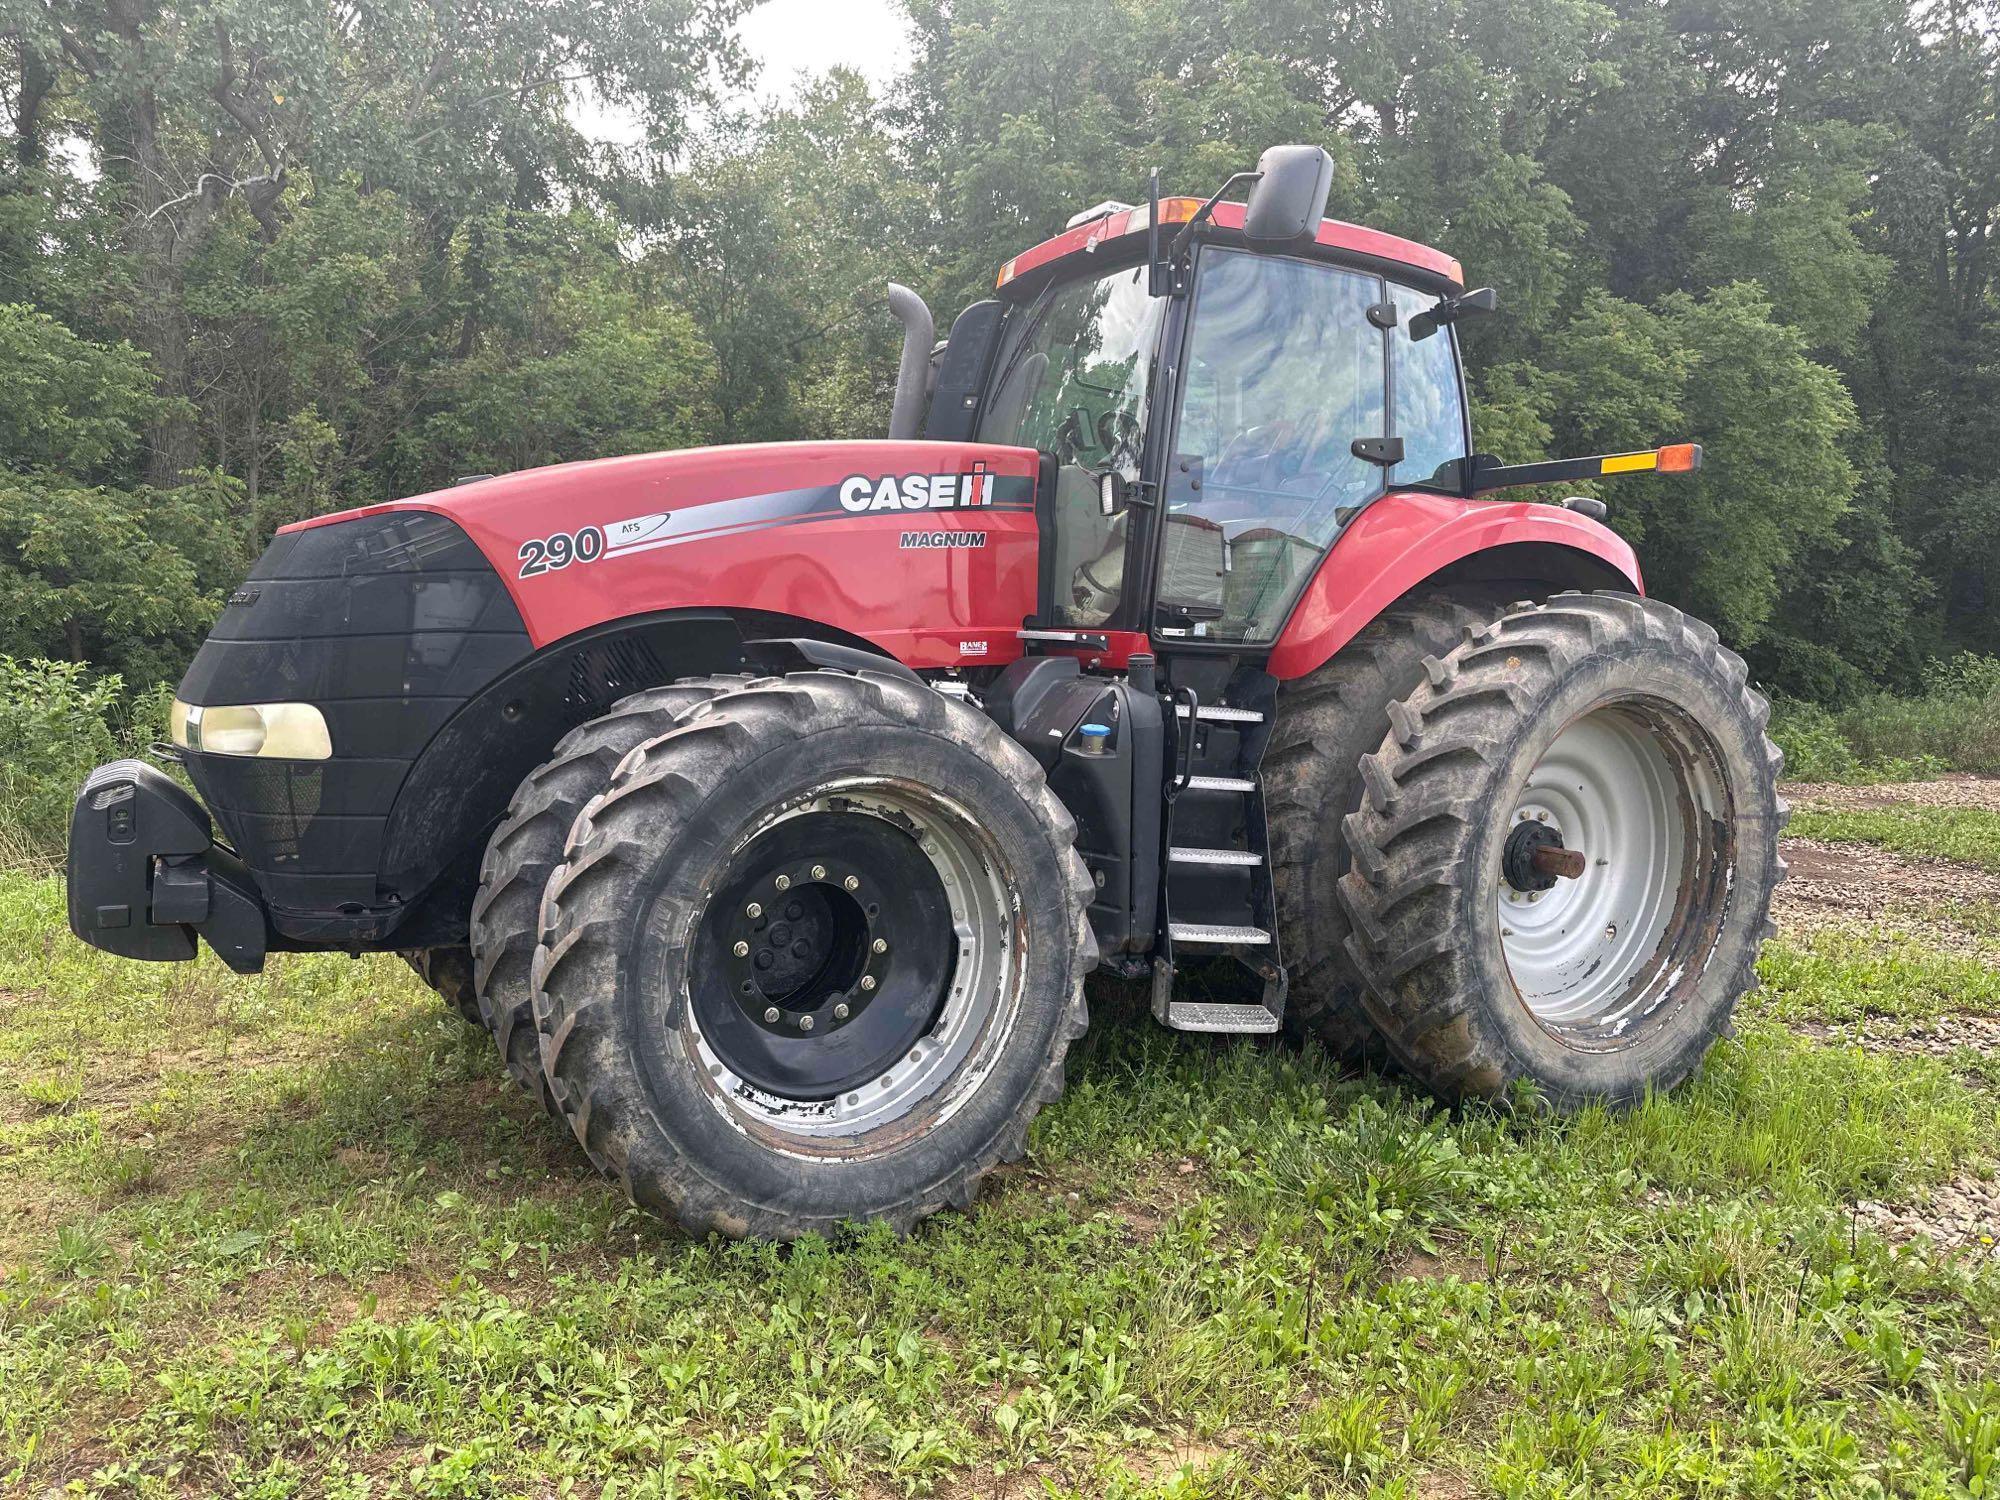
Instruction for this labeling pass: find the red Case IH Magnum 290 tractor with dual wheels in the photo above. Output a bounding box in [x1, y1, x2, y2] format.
[70, 146, 1784, 1238]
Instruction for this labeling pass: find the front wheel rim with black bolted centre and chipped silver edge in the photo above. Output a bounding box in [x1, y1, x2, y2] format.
[688, 782, 1018, 1136]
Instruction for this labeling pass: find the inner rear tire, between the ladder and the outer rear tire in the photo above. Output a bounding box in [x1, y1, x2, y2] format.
[1264, 588, 1506, 1064]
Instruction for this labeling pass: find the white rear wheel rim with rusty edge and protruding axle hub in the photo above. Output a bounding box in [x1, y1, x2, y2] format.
[1494, 698, 1728, 1050]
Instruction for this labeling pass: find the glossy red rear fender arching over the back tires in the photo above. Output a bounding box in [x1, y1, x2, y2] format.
[1266, 494, 1644, 680]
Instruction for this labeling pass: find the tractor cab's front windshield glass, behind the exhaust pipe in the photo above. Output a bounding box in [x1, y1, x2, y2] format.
[980, 266, 1166, 626]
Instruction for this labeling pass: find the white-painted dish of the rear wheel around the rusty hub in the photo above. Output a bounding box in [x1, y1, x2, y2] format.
[1494, 704, 1710, 1046]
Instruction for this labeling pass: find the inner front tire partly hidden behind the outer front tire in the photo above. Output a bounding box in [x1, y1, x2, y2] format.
[466, 676, 750, 1114]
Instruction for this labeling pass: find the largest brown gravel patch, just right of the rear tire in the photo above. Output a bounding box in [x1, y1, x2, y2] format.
[1770, 838, 2000, 952]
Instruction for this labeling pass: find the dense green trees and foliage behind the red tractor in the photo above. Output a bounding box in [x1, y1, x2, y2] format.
[0, 0, 2000, 712]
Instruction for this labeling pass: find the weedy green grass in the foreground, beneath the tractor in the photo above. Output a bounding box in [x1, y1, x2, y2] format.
[0, 876, 2000, 1498]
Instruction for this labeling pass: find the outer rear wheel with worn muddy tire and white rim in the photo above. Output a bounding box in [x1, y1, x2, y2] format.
[1340, 594, 1786, 1110]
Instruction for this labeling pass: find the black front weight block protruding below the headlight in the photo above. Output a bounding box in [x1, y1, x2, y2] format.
[68, 760, 270, 974]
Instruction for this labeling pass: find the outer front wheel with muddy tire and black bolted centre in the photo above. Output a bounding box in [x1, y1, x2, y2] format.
[534, 672, 1096, 1240]
